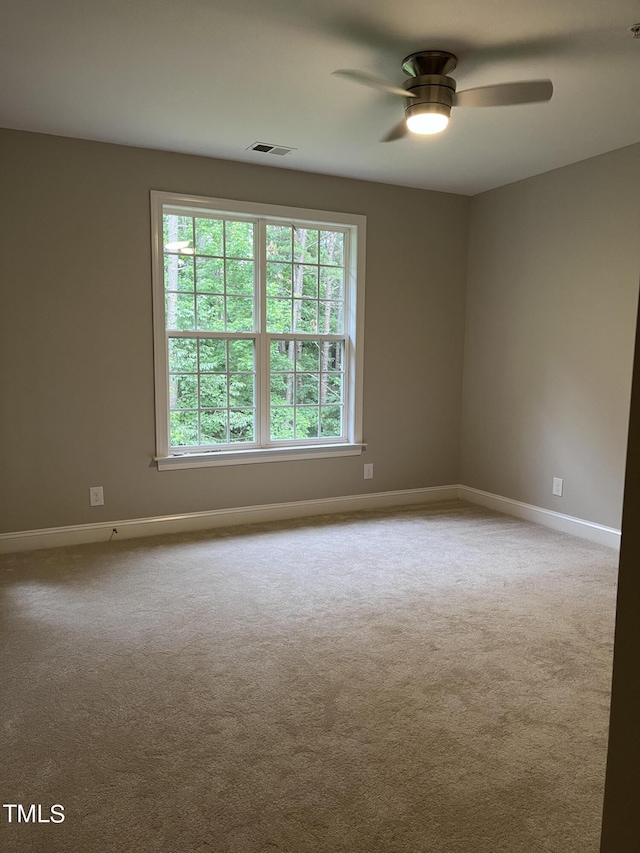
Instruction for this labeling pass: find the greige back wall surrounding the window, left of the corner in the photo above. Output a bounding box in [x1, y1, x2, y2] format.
[0, 131, 469, 532]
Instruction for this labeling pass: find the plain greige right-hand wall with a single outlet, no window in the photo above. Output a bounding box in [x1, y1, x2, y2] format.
[460, 145, 640, 528]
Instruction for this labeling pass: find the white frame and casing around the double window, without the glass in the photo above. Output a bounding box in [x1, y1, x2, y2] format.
[150, 190, 366, 471]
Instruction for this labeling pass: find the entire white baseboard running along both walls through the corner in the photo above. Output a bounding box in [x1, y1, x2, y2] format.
[0, 485, 620, 554]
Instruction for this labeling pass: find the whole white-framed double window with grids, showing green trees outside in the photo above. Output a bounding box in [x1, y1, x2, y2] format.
[151, 192, 365, 469]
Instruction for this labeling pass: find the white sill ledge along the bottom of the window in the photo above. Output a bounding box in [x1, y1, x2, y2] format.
[155, 444, 366, 471]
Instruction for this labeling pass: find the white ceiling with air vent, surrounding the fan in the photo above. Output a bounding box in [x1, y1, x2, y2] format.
[0, 0, 640, 195]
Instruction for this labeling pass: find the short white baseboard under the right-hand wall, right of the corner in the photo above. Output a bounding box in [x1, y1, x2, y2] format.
[458, 486, 621, 549]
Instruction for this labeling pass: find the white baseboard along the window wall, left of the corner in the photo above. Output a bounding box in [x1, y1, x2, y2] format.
[0, 486, 458, 554]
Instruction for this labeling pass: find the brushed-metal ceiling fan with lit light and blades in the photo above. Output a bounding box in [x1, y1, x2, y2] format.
[333, 50, 553, 142]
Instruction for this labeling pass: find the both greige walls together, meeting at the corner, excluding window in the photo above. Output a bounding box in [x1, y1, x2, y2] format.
[0, 131, 640, 532]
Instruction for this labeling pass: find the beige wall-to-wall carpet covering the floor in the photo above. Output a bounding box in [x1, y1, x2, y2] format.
[0, 501, 617, 853]
